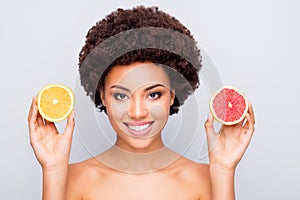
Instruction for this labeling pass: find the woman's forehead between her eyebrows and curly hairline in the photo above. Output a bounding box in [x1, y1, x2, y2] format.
[105, 62, 170, 89]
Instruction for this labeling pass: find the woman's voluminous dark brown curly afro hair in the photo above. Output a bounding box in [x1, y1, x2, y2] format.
[79, 6, 201, 115]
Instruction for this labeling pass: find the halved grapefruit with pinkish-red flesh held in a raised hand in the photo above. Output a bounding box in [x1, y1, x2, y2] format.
[209, 86, 248, 125]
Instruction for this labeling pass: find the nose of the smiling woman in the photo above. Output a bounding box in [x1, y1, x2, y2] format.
[128, 98, 148, 119]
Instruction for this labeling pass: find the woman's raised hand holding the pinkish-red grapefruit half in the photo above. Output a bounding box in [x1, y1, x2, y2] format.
[205, 103, 255, 170]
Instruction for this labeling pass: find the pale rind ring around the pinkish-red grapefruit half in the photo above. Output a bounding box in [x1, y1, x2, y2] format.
[209, 86, 249, 125]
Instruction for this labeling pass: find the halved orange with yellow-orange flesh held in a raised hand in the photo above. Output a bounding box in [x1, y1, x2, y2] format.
[37, 84, 74, 122]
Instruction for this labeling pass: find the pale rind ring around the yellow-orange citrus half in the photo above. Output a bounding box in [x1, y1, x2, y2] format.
[37, 83, 75, 122]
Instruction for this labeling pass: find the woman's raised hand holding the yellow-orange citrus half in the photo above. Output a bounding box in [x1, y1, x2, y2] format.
[28, 97, 75, 170]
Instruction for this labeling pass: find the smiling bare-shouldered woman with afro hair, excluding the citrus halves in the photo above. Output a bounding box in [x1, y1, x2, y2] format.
[28, 7, 254, 200]
